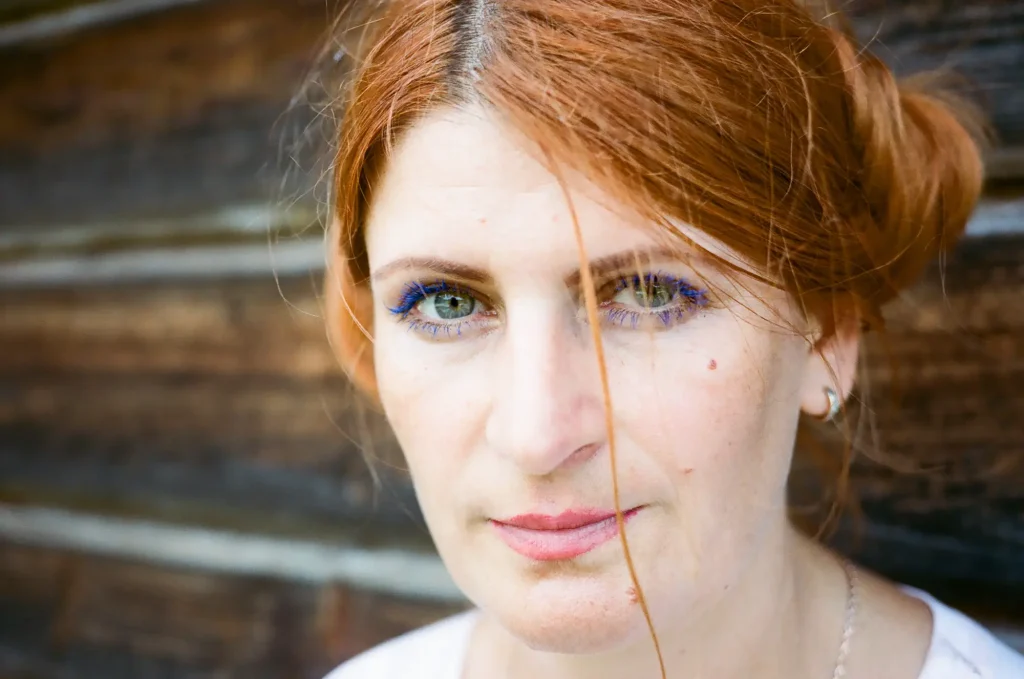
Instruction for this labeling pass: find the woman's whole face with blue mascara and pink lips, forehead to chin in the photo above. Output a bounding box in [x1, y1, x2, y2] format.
[367, 110, 831, 651]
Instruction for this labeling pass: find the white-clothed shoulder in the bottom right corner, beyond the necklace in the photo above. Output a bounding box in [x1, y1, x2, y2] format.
[906, 588, 1024, 679]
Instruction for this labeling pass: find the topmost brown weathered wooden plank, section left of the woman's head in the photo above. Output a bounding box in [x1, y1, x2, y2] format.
[0, 0, 328, 227]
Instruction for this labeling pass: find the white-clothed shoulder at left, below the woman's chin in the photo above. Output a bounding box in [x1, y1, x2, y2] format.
[325, 610, 476, 679]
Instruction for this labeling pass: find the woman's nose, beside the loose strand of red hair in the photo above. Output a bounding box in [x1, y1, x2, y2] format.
[485, 303, 606, 476]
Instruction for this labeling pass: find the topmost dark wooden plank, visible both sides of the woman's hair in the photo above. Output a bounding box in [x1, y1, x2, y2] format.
[0, 0, 1024, 230]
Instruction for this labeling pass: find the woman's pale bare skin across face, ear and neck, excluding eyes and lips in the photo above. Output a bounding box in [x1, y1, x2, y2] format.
[356, 109, 930, 679]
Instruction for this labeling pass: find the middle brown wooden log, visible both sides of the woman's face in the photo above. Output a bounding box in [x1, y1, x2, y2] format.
[0, 236, 1024, 592]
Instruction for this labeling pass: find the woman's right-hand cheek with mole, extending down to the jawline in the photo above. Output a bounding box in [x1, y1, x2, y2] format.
[609, 325, 800, 605]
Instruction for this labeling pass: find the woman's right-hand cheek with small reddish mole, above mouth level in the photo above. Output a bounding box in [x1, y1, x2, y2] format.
[613, 321, 800, 512]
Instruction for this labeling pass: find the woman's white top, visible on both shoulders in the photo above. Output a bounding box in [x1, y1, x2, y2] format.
[326, 588, 1024, 679]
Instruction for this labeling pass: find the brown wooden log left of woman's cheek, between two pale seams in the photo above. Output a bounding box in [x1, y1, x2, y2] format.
[0, 279, 425, 531]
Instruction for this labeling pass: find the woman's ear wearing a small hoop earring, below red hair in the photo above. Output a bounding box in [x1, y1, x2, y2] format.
[801, 320, 860, 418]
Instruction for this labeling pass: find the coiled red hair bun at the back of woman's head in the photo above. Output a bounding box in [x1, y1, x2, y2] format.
[837, 38, 984, 308]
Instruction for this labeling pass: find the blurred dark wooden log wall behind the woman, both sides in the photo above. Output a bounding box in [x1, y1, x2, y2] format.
[0, 0, 1024, 679]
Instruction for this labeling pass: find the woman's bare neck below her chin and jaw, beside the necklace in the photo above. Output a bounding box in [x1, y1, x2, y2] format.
[479, 521, 846, 679]
